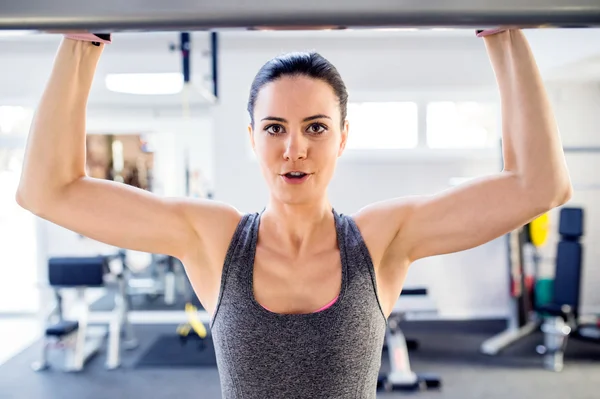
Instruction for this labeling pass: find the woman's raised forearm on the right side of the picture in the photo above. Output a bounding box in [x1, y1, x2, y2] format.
[484, 30, 571, 203]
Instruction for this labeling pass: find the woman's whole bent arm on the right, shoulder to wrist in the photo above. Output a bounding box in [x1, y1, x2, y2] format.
[357, 30, 572, 266]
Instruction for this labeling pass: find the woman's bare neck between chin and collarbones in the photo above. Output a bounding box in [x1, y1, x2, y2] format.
[261, 198, 333, 253]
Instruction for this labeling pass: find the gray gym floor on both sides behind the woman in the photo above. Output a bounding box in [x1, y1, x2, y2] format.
[0, 321, 600, 399]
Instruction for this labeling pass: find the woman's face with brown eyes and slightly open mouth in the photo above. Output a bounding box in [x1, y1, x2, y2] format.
[248, 76, 348, 204]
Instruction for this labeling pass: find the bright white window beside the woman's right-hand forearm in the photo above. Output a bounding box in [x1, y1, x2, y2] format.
[427, 101, 499, 148]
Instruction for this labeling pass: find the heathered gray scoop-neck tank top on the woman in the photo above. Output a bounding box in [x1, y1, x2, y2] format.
[211, 210, 386, 399]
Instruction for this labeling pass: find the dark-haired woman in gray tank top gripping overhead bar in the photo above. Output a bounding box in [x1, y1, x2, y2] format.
[17, 29, 571, 399]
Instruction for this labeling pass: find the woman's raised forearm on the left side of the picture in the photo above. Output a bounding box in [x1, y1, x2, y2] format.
[17, 39, 103, 206]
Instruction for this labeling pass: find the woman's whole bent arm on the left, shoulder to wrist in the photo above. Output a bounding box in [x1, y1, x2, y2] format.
[17, 39, 239, 259]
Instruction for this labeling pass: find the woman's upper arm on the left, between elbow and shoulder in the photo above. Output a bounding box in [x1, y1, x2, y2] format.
[32, 177, 234, 258]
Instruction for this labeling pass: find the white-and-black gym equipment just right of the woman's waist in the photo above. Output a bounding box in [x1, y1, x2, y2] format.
[378, 288, 442, 391]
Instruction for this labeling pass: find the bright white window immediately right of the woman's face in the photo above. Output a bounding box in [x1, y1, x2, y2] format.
[346, 102, 419, 150]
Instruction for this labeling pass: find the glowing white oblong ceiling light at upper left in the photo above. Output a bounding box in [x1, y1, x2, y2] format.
[105, 73, 183, 96]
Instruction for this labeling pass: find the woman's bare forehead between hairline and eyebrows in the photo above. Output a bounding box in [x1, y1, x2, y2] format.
[254, 76, 339, 119]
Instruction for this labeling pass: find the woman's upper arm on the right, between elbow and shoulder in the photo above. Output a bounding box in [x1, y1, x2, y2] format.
[392, 172, 548, 262]
